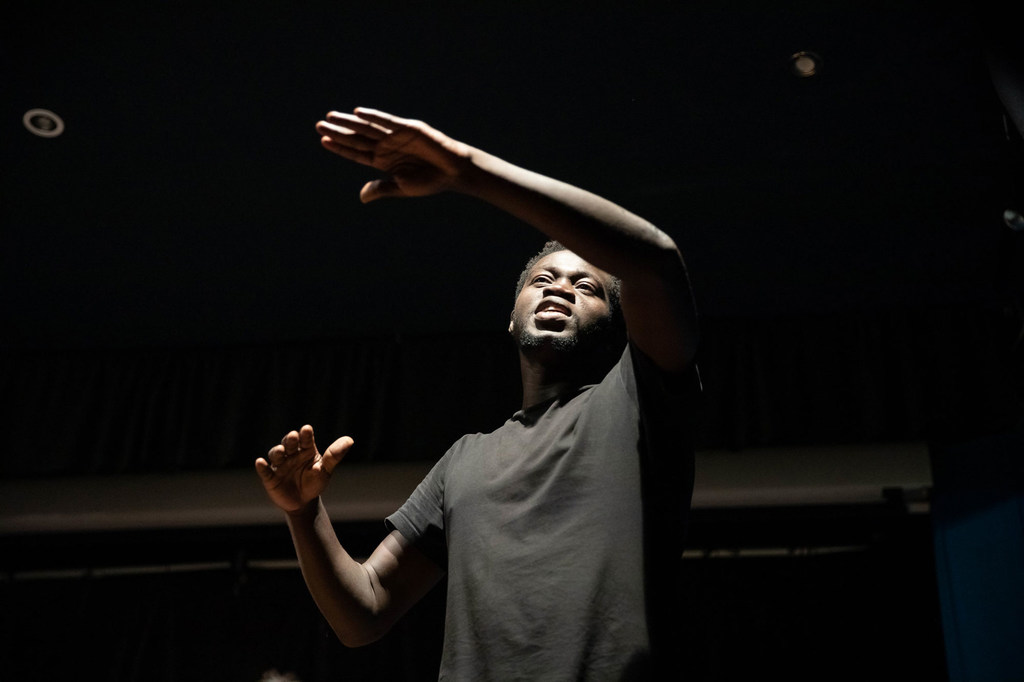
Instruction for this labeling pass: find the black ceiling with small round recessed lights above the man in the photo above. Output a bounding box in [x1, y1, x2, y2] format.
[0, 1, 1020, 347]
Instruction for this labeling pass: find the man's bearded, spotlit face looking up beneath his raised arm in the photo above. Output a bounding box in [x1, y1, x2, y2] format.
[509, 251, 611, 350]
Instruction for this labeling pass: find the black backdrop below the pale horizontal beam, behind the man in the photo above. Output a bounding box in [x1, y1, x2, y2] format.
[0, 506, 944, 682]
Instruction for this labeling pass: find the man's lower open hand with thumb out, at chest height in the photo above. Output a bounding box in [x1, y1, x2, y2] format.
[256, 424, 352, 512]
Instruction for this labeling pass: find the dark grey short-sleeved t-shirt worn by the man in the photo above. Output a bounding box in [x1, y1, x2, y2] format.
[387, 347, 696, 682]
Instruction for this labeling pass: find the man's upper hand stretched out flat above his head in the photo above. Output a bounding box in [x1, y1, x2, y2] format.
[316, 108, 471, 203]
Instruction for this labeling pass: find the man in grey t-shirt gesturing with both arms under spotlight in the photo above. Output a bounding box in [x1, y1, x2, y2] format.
[256, 109, 696, 680]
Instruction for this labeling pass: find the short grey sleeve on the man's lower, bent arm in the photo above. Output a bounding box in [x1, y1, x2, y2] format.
[384, 446, 454, 570]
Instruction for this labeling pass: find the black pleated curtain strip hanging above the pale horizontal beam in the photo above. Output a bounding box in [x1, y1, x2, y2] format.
[0, 305, 1019, 478]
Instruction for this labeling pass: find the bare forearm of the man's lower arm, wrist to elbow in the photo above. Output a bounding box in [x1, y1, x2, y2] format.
[288, 499, 386, 646]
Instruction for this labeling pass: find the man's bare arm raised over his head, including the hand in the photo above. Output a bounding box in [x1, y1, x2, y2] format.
[316, 109, 697, 371]
